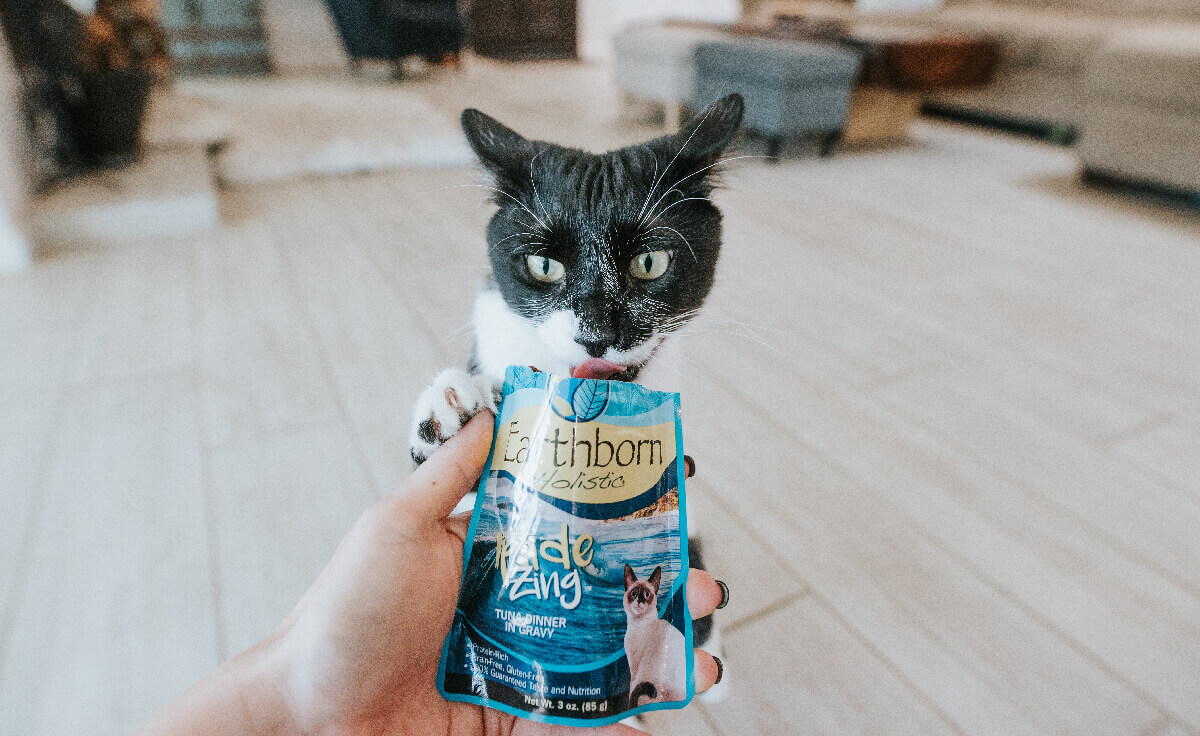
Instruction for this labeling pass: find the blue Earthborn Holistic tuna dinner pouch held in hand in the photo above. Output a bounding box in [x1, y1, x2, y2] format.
[438, 366, 695, 725]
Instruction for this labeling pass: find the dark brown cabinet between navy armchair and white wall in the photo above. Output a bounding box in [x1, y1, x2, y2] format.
[470, 0, 577, 61]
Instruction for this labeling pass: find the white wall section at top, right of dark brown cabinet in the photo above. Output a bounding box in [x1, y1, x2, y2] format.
[578, 0, 742, 59]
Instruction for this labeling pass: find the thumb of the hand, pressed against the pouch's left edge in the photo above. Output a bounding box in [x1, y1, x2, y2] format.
[398, 409, 494, 521]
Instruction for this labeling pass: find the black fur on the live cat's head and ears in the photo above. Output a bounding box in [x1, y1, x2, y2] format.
[462, 95, 744, 379]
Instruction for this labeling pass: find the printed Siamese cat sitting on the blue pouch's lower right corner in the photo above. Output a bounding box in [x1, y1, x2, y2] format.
[624, 564, 688, 708]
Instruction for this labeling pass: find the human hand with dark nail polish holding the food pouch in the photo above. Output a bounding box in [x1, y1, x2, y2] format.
[138, 412, 722, 736]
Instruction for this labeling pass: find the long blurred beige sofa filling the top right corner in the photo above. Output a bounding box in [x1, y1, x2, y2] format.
[764, 0, 1200, 192]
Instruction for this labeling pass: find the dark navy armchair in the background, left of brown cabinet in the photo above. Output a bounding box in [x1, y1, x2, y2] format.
[326, 0, 466, 61]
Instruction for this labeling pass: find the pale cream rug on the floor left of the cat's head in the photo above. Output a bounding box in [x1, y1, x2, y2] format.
[160, 78, 472, 186]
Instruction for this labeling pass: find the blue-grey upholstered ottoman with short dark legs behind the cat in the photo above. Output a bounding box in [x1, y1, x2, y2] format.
[694, 38, 862, 156]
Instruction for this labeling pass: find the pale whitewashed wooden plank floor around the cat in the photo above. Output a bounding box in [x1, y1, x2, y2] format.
[0, 62, 1200, 736]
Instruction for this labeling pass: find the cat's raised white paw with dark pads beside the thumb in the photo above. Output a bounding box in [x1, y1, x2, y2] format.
[408, 369, 500, 462]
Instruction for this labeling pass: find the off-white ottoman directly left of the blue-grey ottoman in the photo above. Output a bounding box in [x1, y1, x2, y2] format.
[612, 24, 727, 132]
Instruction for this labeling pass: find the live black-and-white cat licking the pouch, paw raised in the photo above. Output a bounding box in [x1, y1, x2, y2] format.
[410, 95, 743, 696]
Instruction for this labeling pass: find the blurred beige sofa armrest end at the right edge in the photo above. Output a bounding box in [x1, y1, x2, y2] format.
[1079, 25, 1200, 203]
